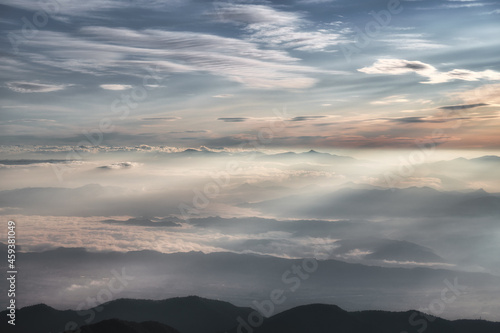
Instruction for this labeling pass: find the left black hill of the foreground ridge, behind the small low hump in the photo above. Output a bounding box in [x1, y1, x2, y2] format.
[0, 296, 252, 333]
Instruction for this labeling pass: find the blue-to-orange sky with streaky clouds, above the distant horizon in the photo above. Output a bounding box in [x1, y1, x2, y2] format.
[0, 0, 500, 150]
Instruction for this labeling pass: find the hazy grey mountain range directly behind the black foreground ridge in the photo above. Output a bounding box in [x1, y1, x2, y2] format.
[5, 248, 500, 322]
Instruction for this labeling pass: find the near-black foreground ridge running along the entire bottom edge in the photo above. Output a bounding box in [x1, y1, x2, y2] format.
[0, 296, 500, 333]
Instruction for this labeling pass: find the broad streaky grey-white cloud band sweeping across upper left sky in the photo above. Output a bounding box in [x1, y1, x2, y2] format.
[16, 26, 324, 89]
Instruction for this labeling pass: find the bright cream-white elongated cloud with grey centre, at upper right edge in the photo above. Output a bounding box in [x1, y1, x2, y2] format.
[358, 59, 500, 84]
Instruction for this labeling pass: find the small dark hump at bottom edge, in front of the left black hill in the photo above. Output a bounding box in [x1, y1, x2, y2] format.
[67, 319, 179, 333]
